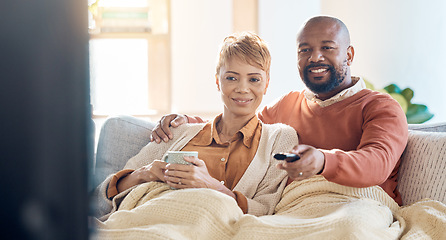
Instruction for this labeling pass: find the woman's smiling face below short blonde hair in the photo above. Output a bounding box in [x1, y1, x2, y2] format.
[216, 58, 269, 117]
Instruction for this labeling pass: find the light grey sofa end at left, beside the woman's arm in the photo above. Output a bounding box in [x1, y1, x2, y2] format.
[94, 115, 155, 186]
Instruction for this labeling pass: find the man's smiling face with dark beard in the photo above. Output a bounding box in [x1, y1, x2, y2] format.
[297, 22, 351, 96]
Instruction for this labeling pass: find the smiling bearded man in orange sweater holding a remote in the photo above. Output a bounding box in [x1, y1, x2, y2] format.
[152, 16, 408, 204]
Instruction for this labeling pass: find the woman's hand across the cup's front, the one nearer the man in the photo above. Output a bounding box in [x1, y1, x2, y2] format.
[164, 156, 235, 198]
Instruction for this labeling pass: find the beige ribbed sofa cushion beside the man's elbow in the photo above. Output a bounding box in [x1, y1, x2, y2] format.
[398, 130, 446, 205]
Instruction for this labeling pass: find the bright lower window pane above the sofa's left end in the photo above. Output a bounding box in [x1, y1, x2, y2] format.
[90, 39, 149, 115]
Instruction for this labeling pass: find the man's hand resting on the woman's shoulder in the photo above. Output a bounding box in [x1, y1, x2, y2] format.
[150, 113, 187, 143]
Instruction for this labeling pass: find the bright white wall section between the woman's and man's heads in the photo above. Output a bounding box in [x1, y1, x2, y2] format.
[259, 0, 320, 108]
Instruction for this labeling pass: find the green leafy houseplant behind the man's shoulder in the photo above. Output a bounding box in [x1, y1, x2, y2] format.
[364, 79, 434, 124]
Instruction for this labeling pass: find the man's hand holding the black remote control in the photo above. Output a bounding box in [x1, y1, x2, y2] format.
[277, 144, 325, 180]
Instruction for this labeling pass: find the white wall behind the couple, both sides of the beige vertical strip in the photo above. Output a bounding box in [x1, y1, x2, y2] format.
[172, 0, 446, 122]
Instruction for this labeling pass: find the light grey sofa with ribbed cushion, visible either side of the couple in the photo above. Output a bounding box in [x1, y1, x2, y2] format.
[93, 115, 446, 205]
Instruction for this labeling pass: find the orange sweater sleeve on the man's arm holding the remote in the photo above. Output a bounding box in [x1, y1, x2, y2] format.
[321, 94, 408, 190]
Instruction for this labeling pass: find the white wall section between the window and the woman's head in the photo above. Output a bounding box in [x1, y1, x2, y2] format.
[171, 0, 232, 115]
